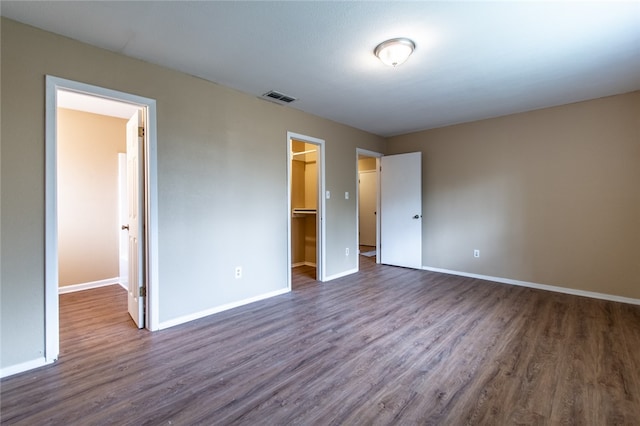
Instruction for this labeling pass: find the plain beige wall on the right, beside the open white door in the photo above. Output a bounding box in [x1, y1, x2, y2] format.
[388, 92, 640, 298]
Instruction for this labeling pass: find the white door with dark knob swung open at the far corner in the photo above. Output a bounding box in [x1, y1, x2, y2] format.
[380, 152, 422, 268]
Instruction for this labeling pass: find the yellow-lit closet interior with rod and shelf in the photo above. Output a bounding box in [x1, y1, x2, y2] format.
[291, 141, 318, 267]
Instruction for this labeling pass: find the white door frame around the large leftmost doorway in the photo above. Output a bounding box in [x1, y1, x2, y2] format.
[45, 75, 159, 363]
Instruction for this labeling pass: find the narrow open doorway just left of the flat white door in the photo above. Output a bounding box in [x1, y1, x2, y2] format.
[357, 149, 382, 263]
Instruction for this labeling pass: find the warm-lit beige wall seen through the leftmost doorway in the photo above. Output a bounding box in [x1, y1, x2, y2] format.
[57, 108, 127, 286]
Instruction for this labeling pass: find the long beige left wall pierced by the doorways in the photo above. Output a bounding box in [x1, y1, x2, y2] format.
[0, 18, 386, 368]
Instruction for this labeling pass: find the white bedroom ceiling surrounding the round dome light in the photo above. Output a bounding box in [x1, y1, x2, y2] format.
[0, 0, 640, 136]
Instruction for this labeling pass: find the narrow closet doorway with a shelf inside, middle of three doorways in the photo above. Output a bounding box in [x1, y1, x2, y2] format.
[288, 133, 325, 288]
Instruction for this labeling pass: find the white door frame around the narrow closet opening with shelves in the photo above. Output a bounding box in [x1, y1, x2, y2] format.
[287, 132, 326, 290]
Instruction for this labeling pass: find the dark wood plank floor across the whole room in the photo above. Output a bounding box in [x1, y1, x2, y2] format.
[1, 257, 640, 425]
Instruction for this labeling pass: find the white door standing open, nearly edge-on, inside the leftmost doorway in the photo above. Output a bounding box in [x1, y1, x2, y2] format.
[127, 114, 145, 328]
